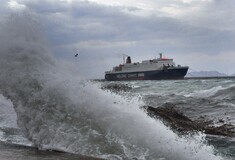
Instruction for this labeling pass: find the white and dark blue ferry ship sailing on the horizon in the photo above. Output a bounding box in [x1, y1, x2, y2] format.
[105, 53, 189, 81]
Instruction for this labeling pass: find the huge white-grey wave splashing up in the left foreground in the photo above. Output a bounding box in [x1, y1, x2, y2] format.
[0, 13, 225, 160]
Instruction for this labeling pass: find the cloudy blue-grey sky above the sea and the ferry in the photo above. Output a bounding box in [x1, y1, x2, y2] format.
[0, 0, 235, 78]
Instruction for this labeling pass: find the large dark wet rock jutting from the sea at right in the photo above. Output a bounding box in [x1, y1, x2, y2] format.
[143, 104, 235, 137]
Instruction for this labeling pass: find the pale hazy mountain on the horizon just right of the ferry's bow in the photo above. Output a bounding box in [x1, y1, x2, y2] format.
[186, 71, 228, 77]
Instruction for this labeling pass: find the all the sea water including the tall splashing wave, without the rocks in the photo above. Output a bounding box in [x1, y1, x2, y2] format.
[0, 11, 235, 160]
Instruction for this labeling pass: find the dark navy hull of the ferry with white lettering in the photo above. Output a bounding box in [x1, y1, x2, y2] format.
[105, 67, 188, 81]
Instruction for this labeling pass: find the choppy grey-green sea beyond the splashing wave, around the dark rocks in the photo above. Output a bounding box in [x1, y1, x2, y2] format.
[103, 78, 235, 159]
